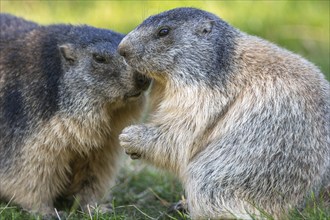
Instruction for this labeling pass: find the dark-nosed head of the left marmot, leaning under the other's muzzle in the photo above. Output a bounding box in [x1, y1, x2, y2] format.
[58, 26, 150, 111]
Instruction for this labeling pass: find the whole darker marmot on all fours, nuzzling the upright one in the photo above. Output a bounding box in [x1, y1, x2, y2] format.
[0, 14, 148, 217]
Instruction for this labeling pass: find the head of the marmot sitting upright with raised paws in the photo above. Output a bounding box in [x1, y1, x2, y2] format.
[118, 8, 239, 85]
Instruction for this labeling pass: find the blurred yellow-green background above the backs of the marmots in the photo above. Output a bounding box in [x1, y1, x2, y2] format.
[0, 0, 330, 80]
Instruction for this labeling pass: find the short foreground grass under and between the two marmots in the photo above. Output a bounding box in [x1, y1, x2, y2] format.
[0, 158, 330, 220]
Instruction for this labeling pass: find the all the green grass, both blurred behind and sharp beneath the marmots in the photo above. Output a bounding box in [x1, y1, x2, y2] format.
[0, 0, 330, 220]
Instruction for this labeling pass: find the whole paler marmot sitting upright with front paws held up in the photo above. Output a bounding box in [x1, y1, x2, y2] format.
[118, 8, 330, 219]
